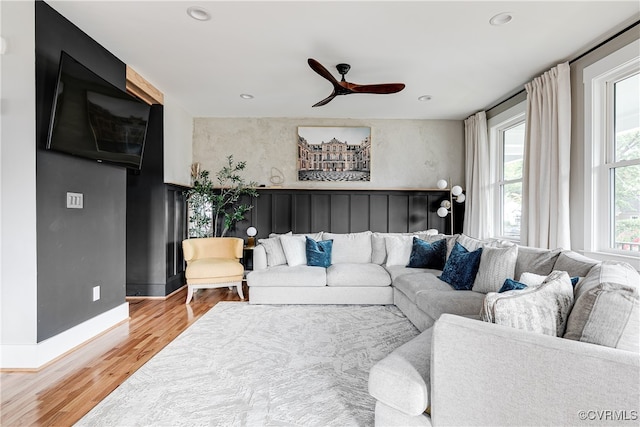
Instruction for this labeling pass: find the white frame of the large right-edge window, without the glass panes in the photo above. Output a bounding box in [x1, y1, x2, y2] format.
[583, 40, 640, 265]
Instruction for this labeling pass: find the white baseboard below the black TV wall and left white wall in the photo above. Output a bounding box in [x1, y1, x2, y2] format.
[0, 302, 129, 370]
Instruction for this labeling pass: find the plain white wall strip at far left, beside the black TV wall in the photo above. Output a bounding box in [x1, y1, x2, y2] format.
[0, 1, 37, 346]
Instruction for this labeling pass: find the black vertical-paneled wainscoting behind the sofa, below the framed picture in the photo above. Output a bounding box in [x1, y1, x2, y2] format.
[230, 188, 464, 242]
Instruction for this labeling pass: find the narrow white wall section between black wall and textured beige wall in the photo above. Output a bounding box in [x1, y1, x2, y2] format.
[164, 95, 193, 186]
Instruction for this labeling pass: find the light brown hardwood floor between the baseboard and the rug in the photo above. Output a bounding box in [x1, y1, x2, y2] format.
[0, 285, 247, 426]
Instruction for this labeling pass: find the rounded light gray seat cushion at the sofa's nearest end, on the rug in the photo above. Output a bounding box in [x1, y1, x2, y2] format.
[369, 328, 432, 416]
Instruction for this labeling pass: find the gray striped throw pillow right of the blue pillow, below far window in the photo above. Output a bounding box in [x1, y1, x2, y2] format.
[473, 245, 518, 294]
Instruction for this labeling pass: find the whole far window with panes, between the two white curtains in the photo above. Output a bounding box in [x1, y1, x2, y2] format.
[487, 102, 526, 241]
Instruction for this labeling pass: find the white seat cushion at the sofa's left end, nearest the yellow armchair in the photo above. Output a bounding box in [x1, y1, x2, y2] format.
[247, 265, 327, 287]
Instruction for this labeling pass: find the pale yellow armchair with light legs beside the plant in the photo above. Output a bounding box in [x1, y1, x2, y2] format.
[182, 237, 244, 304]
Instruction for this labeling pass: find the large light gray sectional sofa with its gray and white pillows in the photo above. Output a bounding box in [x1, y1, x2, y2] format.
[247, 231, 640, 426]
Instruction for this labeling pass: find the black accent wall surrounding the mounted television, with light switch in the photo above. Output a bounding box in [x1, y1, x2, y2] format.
[36, 1, 127, 342]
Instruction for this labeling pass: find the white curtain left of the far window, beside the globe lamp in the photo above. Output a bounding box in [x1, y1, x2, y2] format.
[463, 111, 493, 239]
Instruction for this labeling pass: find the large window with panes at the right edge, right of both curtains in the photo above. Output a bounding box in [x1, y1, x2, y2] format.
[584, 42, 640, 257]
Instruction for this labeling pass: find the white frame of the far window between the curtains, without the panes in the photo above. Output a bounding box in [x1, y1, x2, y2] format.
[487, 100, 527, 243]
